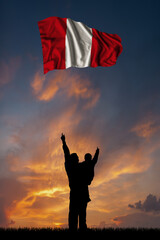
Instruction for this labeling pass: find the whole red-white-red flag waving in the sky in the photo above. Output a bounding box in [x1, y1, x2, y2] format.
[38, 17, 122, 73]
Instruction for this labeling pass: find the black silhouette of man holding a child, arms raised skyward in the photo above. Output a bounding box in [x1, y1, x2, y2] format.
[61, 134, 99, 230]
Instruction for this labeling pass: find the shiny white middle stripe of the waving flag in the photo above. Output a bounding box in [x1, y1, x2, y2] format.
[65, 18, 92, 68]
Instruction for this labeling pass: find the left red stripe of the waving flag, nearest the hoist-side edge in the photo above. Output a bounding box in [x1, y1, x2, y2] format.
[38, 17, 67, 73]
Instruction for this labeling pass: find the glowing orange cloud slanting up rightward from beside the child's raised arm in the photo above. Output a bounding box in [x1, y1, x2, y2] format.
[89, 144, 153, 190]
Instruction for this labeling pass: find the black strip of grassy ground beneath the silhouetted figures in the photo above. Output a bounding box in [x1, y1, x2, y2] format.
[0, 228, 160, 236]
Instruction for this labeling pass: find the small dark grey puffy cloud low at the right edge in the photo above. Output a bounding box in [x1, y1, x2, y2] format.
[128, 194, 160, 212]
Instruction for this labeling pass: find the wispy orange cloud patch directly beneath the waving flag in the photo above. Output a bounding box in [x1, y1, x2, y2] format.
[31, 71, 100, 109]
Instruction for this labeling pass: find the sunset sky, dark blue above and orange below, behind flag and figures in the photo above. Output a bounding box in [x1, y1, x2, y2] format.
[0, 0, 160, 227]
